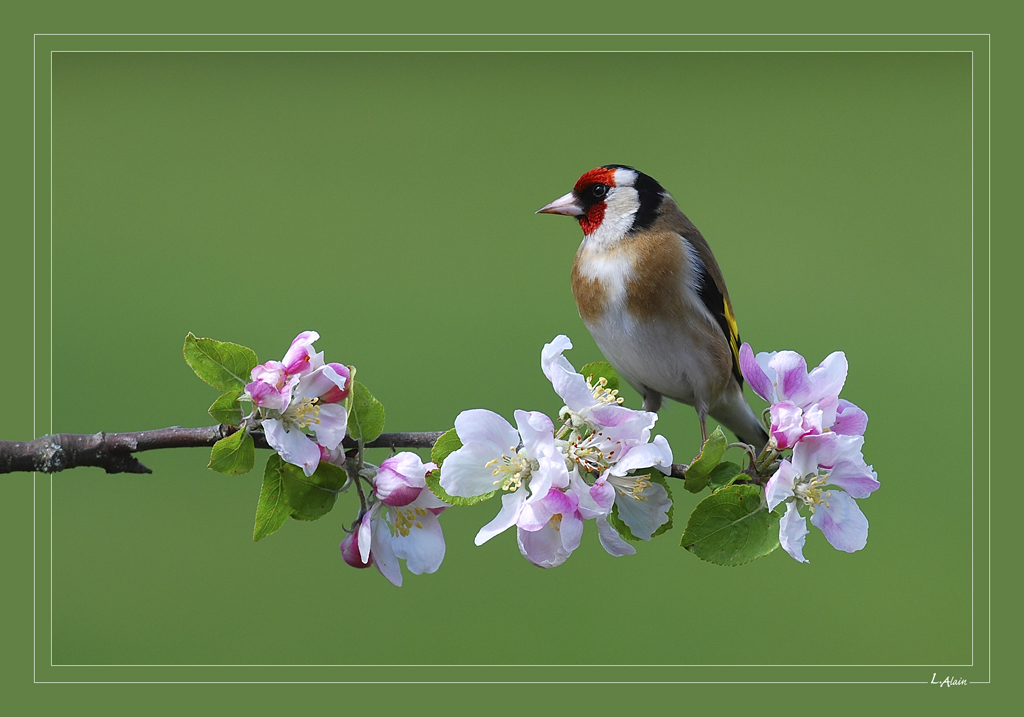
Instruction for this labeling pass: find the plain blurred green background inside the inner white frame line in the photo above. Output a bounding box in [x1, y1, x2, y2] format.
[4, 5, 1015, 712]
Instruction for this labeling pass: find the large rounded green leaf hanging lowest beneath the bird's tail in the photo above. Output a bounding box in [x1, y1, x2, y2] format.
[679, 486, 778, 565]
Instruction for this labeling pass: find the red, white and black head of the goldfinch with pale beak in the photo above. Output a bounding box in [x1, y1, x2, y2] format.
[537, 164, 666, 240]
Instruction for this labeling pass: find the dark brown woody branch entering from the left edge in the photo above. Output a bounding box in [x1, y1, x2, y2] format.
[0, 424, 443, 473]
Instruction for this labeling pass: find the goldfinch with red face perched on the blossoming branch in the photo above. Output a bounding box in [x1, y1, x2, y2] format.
[537, 164, 768, 451]
